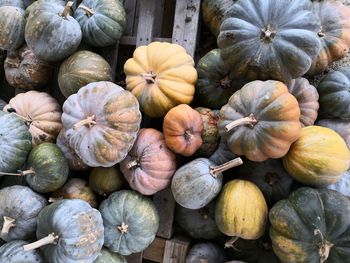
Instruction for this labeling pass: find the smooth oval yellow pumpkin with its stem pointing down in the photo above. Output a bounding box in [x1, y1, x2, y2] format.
[215, 179, 268, 247]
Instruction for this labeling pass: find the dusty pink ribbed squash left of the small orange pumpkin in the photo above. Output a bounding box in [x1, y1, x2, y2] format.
[120, 128, 176, 195]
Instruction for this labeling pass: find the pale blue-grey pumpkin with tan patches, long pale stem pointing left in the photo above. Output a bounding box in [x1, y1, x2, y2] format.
[23, 199, 104, 263]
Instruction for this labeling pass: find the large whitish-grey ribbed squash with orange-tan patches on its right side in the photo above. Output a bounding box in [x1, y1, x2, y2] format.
[62, 81, 141, 167]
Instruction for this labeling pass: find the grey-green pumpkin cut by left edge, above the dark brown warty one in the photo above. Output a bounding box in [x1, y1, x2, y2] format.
[0, 5, 26, 50]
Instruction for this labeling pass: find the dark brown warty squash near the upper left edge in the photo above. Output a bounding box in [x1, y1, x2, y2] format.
[4, 45, 53, 90]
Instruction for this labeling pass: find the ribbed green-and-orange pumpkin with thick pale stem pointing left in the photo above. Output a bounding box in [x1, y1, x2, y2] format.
[218, 80, 301, 162]
